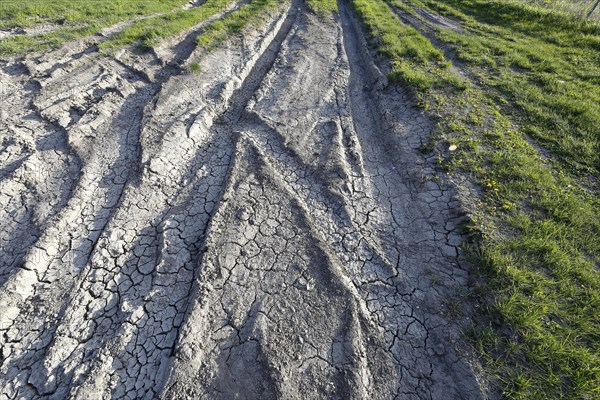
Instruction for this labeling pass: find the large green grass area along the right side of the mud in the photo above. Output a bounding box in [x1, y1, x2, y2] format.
[352, 0, 600, 399]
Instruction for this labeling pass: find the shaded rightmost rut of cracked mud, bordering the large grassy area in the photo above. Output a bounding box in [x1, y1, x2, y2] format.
[341, 2, 482, 399]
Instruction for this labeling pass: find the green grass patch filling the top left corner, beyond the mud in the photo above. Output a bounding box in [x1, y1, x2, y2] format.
[0, 0, 186, 57]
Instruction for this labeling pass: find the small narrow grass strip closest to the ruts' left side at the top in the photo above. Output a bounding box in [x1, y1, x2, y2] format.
[196, 0, 282, 49]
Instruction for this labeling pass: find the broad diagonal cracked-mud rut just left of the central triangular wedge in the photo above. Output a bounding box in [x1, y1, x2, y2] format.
[3, 2, 290, 398]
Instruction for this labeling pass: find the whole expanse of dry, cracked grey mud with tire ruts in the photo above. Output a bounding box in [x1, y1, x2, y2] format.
[0, 2, 483, 399]
